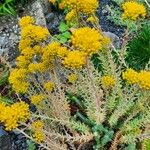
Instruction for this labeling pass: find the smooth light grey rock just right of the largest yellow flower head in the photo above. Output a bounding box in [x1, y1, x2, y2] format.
[103, 32, 120, 48]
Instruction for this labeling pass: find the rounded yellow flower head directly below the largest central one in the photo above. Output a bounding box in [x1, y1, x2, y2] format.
[63, 50, 86, 69]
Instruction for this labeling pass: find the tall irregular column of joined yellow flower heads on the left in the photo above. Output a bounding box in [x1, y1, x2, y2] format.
[9, 16, 49, 93]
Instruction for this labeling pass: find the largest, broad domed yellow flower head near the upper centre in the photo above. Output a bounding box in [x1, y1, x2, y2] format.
[71, 27, 109, 55]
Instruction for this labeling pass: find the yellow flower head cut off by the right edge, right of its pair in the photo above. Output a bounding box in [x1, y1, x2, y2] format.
[138, 71, 150, 90]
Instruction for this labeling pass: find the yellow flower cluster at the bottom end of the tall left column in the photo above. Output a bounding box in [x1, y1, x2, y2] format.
[9, 69, 29, 93]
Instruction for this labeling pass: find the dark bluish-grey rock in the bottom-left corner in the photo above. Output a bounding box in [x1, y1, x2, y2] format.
[0, 126, 12, 150]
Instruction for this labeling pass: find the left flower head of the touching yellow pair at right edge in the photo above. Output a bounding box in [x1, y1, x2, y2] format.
[122, 69, 138, 84]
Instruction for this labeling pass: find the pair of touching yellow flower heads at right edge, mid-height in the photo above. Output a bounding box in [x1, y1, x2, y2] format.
[122, 69, 150, 90]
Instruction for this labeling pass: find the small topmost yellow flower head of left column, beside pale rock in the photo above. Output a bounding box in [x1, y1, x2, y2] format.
[19, 16, 35, 28]
